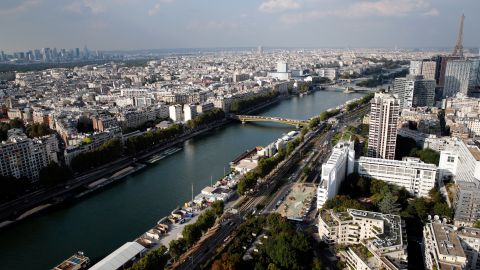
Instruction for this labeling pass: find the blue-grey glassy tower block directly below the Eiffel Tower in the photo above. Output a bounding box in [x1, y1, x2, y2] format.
[443, 60, 472, 97]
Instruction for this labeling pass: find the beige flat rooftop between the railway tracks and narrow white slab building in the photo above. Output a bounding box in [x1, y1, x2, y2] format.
[277, 183, 317, 221]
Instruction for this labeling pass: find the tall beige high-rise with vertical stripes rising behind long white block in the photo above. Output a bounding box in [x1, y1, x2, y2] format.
[367, 93, 400, 159]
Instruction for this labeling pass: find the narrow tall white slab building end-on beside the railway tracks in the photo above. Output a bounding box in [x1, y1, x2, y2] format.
[317, 141, 355, 209]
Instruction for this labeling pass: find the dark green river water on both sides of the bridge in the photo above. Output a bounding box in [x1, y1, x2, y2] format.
[0, 91, 361, 270]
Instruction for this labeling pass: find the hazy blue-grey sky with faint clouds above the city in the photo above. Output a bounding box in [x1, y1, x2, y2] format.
[0, 0, 480, 52]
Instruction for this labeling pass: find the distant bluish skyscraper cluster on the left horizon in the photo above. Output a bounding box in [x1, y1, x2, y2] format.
[0, 47, 104, 63]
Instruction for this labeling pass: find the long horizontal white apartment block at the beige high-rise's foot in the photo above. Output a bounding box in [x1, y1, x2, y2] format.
[356, 157, 437, 197]
